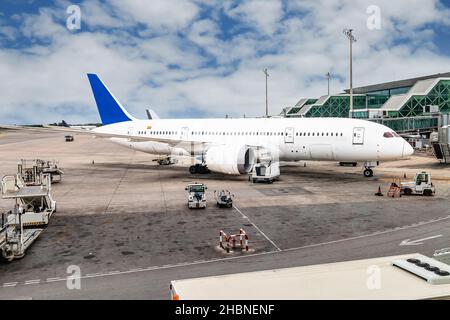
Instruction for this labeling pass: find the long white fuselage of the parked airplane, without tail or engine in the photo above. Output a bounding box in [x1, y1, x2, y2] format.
[93, 118, 413, 161]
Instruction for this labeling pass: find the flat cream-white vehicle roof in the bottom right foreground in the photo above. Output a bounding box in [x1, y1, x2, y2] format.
[172, 254, 450, 300]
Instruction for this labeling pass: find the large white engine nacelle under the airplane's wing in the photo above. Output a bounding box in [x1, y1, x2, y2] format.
[204, 145, 257, 175]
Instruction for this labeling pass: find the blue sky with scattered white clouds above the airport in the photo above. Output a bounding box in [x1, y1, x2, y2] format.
[0, 0, 450, 124]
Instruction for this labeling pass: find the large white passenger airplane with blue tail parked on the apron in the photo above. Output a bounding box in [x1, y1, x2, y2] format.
[0, 73, 414, 177]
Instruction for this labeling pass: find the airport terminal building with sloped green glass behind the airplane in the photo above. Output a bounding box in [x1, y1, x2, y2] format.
[282, 72, 450, 133]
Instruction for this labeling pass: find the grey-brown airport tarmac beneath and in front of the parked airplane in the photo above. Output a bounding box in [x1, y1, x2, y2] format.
[0, 131, 450, 299]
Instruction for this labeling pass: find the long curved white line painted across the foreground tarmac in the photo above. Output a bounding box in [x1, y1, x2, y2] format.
[3, 212, 450, 287]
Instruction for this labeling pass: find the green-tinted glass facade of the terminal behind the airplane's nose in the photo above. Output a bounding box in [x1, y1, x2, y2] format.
[287, 77, 450, 131]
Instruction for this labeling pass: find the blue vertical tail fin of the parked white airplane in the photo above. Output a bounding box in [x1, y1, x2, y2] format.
[88, 73, 134, 125]
